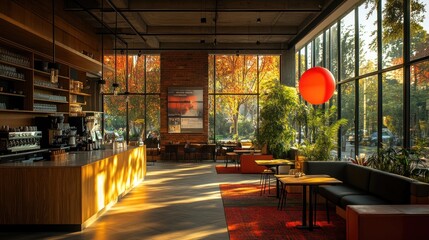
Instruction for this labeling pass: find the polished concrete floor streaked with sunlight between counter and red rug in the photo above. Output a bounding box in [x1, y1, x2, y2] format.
[0, 161, 259, 240]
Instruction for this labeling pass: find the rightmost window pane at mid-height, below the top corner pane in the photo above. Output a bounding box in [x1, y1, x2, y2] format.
[410, 61, 429, 146]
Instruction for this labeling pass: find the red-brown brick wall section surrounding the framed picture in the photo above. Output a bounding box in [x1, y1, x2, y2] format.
[160, 51, 208, 146]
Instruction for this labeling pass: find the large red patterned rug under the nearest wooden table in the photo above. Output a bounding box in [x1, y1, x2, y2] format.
[220, 184, 346, 240]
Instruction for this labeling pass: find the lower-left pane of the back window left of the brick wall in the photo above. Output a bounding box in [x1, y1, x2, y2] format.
[103, 95, 127, 140]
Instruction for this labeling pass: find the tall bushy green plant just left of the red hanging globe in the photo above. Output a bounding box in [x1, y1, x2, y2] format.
[258, 81, 298, 158]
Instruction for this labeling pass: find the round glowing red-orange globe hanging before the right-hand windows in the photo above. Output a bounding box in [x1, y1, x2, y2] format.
[299, 67, 335, 105]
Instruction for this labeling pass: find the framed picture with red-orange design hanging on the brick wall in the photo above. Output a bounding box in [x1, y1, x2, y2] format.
[167, 87, 204, 133]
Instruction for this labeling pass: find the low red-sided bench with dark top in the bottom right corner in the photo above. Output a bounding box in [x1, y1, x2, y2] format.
[346, 204, 429, 240]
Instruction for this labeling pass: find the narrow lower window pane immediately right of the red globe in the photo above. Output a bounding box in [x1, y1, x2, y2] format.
[341, 81, 356, 159]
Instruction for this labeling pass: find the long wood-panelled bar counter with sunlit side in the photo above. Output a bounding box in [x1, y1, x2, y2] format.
[0, 146, 146, 231]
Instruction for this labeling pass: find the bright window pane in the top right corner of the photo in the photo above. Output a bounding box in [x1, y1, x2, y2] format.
[410, 0, 429, 59]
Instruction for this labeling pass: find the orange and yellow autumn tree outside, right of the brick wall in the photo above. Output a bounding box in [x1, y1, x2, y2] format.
[215, 55, 279, 141]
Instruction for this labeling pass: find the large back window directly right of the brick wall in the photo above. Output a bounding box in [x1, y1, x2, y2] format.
[208, 55, 280, 141]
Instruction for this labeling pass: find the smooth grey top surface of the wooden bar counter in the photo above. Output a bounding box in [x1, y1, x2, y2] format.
[0, 146, 136, 168]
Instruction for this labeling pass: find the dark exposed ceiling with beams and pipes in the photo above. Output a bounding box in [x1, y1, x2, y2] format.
[65, 0, 345, 52]
